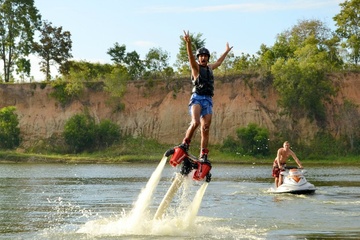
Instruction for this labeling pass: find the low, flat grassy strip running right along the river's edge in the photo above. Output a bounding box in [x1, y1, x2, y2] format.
[0, 150, 360, 167]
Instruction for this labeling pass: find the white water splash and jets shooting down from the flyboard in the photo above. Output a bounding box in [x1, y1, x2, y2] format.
[77, 157, 210, 236]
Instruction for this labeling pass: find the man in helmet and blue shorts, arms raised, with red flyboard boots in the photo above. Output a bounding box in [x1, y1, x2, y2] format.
[165, 31, 233, 182]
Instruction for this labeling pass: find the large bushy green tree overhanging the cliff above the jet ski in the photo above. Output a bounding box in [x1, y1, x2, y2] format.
[271, 41, 336, 126]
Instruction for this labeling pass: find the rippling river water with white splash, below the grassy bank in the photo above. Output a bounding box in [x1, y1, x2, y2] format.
[0, 162, 360, 240]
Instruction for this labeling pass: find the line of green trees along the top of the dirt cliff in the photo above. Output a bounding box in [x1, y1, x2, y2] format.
[0, 0, 360, 82]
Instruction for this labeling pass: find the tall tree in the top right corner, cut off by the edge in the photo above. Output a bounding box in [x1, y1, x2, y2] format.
[333, 0, 360, 65]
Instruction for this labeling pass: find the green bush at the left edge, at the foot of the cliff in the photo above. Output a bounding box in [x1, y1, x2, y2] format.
[0, 106, 20, 149]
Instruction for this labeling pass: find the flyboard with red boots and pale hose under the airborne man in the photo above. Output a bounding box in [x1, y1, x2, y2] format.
[154, 147, 211, 219]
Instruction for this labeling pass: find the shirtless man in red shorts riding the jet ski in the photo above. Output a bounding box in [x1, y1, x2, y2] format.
[272, 141, 303, 187]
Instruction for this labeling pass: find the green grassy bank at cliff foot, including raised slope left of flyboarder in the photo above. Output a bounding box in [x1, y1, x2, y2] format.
[0, 138, 360, 166]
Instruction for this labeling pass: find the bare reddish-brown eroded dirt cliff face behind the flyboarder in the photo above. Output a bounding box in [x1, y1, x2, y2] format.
[0, 73, 360, 146]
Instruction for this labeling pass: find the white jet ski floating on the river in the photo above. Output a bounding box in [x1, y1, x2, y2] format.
[273, 168, 316, 194]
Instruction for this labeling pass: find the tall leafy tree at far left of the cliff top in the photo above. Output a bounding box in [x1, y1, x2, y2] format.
[0, 0, 41, 82]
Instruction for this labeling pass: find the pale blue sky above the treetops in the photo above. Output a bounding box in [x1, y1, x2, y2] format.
[32, 0, 345, 80]
